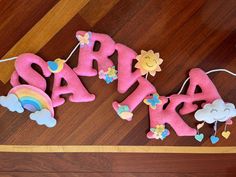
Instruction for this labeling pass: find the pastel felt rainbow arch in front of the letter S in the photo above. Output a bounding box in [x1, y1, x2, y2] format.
[9, 85, 54, 116]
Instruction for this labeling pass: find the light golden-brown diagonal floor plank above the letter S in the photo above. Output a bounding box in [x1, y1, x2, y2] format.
[0, 0, 88, 83]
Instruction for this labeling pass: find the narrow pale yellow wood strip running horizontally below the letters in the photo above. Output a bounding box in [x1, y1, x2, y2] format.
[0, 145, 236, 154]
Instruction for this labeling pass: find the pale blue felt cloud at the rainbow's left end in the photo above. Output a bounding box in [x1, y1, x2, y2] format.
[0, 94, 24, 113]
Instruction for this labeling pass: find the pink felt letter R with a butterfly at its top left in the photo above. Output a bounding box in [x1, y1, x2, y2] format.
[74, 31, 115, 76]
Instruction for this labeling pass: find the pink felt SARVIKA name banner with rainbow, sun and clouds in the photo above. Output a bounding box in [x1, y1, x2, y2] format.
[0, 31, 236, 144]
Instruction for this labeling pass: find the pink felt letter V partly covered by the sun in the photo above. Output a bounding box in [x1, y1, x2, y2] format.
[116, 44, 141, 93]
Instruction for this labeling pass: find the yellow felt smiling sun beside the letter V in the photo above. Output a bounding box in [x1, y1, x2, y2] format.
[135, 50, 163, 76]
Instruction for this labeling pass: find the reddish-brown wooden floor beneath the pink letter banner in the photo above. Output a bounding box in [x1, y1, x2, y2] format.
[0, 0, 236, 177]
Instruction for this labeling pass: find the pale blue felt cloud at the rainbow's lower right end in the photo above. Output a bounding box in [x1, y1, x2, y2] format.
[30, 109, 57, 128]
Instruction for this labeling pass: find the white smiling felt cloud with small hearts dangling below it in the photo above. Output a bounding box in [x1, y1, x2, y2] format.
[194, 99, 236, 124]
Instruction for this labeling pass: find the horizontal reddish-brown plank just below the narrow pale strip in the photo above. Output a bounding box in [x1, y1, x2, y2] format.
[0, 153, 236, 174]
